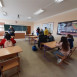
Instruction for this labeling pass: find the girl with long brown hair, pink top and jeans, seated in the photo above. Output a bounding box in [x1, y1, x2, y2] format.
[53, 37, 70, 63]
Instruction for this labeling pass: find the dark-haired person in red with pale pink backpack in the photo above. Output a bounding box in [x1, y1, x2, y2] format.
[0, 33, 16, 48]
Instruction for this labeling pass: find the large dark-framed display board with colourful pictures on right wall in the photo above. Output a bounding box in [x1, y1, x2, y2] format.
[57, 20, 77, 36]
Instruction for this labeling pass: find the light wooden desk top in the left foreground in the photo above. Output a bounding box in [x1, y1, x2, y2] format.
[0, 46, 22, 60]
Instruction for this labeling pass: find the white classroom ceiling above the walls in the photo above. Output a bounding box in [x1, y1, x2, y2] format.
[0, 0, 77, 21]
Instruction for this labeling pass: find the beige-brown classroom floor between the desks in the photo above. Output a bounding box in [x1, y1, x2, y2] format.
[3, 40, 77, 77]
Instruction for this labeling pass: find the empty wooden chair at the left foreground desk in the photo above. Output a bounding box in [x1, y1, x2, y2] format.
[0, 57, 20, 77]
